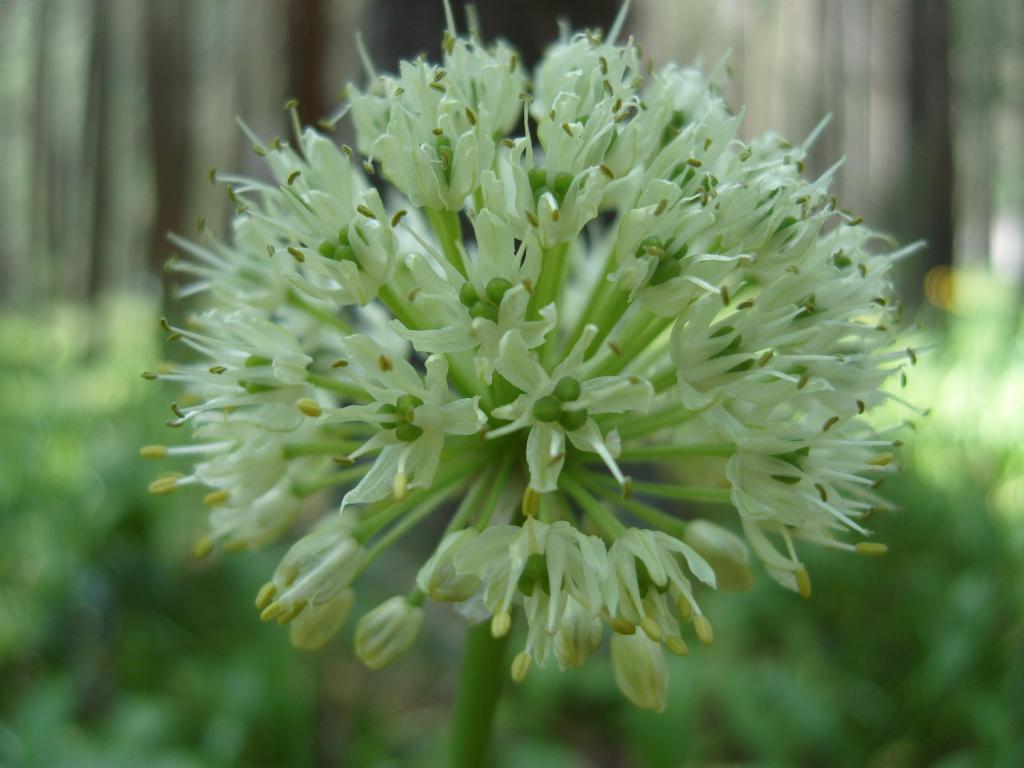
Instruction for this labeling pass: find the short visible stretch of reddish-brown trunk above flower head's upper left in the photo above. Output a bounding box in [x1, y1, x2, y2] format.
[288, 0, 329, 125]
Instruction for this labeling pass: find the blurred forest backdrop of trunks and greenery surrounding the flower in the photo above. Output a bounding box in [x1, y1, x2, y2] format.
[0, 0, 1024, 768]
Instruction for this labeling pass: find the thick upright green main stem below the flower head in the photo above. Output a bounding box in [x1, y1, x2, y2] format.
[451, 622, 508, 768]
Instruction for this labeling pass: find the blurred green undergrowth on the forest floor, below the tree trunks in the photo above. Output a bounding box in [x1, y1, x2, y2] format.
[0, 286, 1024, 768]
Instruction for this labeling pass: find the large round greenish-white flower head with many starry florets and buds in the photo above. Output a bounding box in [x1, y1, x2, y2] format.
[143, 7, 913, 709]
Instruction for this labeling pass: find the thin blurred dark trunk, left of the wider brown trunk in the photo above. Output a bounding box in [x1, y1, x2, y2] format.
[82, 0, 112, 302]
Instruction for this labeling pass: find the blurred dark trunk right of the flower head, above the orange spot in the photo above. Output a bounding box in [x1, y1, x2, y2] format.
[908, 0, 953, 300]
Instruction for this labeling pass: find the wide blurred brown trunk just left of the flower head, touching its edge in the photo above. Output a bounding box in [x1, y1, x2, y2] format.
[146, 0, 193, 290]
